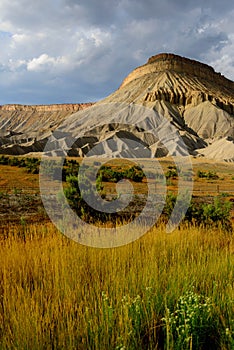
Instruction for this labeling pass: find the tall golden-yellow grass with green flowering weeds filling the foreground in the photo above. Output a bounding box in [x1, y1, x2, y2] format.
[0, 224, 234, 350]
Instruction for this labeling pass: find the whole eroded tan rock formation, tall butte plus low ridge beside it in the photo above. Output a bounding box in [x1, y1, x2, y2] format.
[0, 53, 234, 161]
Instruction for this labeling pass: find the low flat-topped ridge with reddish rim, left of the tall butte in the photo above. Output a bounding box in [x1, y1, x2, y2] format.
[0, 103, 93, 154]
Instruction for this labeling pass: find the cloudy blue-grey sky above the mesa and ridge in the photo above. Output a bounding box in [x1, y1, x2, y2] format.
[0, 0, 234, 105]
